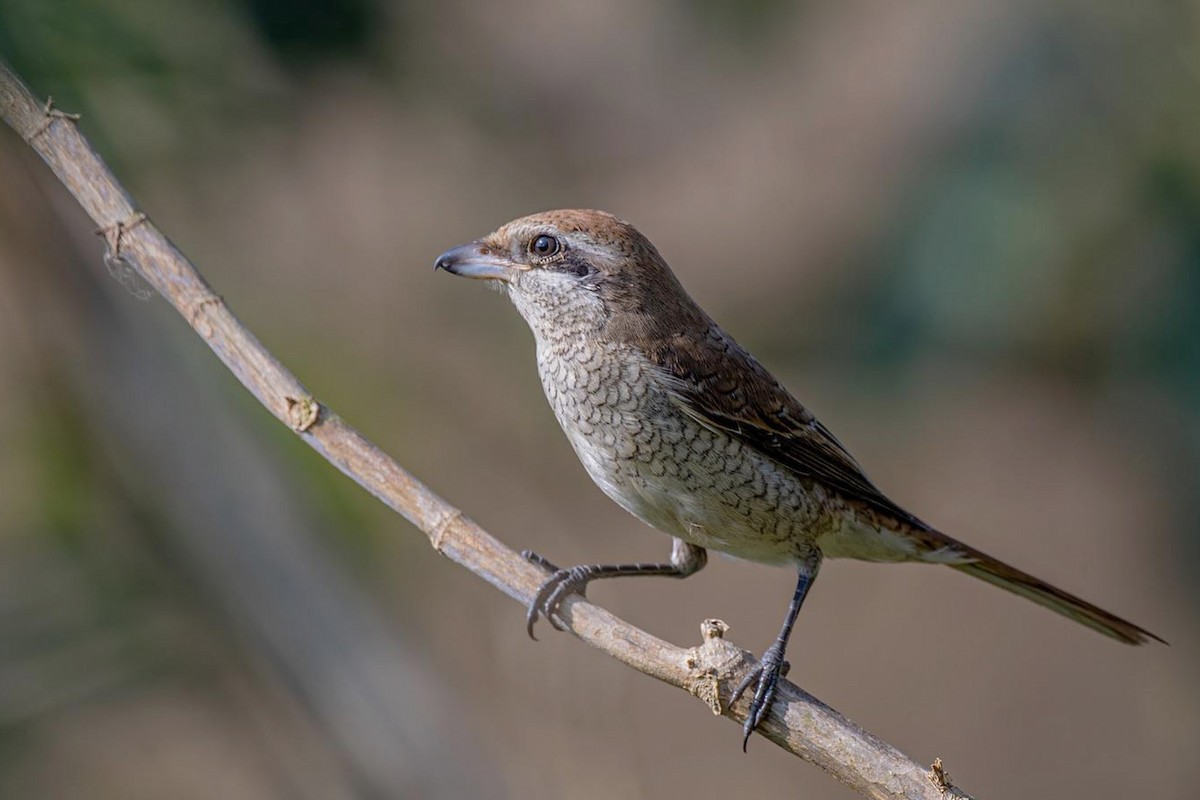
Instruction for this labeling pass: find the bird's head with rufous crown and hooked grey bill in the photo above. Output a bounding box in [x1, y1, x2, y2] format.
[433, 210, 703, 336]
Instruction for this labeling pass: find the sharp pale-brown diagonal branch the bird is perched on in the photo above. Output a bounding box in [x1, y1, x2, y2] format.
[0, 61, 967, 800]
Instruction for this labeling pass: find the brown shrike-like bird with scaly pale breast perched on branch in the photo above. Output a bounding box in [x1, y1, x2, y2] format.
[434, 210, 1163, 750]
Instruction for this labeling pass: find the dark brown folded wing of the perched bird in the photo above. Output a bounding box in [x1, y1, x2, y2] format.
[648, 325, 929, 530]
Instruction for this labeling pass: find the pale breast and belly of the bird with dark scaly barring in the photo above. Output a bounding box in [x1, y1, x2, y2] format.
[539, 345, 919, 565]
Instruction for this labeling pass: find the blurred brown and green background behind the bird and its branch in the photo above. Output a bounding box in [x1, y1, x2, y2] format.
[0, 0, 1200, 800]
